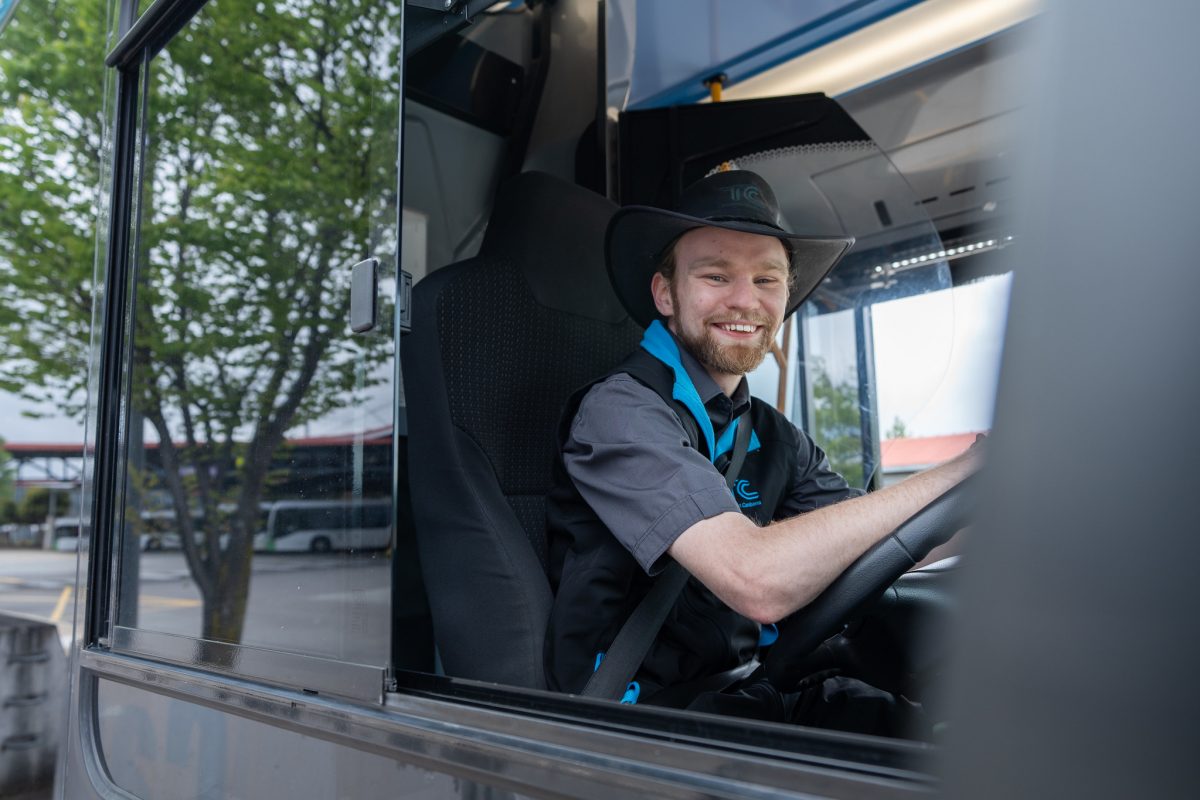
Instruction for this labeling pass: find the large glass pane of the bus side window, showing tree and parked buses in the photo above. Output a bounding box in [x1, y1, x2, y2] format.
[118, 0, 400, 664]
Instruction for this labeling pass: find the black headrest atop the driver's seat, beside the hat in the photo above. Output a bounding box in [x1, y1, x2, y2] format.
[479, 173, 628, 323]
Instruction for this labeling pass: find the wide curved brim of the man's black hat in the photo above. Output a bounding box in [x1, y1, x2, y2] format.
[605, 205, 854, 327]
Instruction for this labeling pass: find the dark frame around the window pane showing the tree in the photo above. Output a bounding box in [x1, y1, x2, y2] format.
[92, 0, 403, 704]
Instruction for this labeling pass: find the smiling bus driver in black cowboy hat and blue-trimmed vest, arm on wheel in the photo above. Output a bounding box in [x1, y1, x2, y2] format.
[546, 170, 977, 733]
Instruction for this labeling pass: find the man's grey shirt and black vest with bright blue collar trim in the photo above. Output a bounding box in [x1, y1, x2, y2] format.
[546, 329, 859, 697]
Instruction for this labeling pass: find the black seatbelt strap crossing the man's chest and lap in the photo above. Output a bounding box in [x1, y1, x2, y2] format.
[582, 413, 752, 700]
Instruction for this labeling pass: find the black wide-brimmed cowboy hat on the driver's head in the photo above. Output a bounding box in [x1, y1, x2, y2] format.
[605, 169, 854, 327]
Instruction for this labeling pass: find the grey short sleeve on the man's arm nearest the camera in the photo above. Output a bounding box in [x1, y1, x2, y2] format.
[563, 375, 739, 575]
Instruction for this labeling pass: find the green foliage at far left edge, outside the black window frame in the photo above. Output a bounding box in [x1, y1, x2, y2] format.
[0, 0, 106, 416]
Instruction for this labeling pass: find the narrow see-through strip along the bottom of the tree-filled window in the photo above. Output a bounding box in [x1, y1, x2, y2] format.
[113, 626, 385, 703]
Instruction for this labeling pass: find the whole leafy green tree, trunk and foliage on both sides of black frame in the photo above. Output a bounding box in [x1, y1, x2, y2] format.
[0, 0, 400, 642]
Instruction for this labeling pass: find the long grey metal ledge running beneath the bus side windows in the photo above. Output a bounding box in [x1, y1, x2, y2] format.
[79, 650, 931, 800]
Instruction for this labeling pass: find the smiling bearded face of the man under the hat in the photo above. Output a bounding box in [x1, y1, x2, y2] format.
[650, 228, 788, 381]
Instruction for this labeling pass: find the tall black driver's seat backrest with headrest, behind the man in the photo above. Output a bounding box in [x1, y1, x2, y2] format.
[402, 173, 641, 688]
